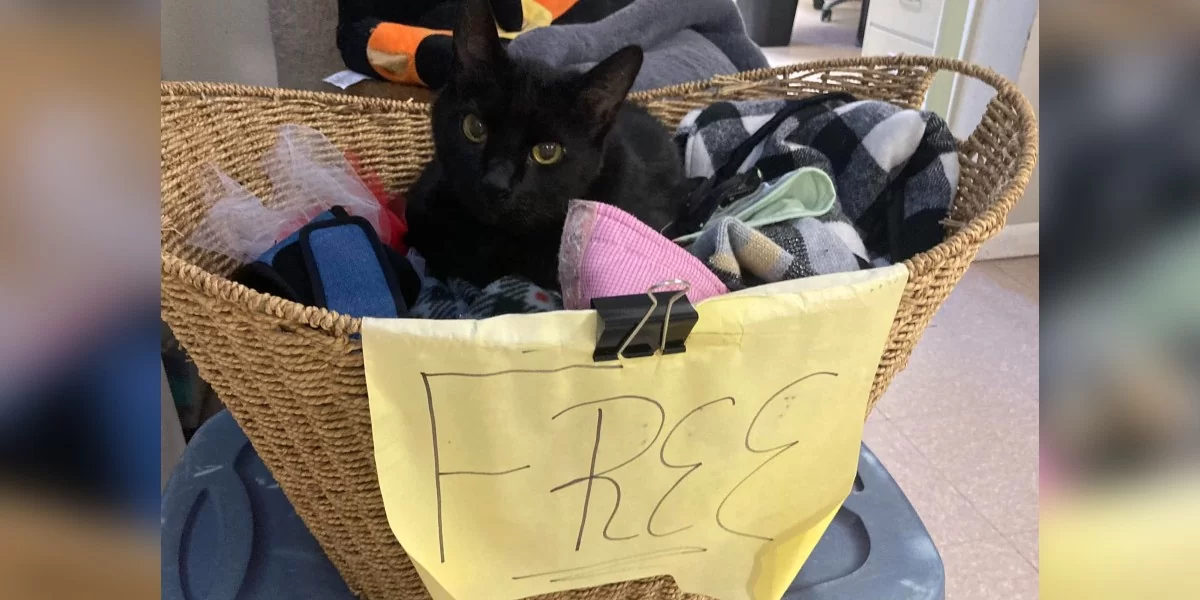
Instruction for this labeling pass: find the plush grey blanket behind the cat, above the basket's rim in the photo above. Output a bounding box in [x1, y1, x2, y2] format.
[509, 0, 767, 90]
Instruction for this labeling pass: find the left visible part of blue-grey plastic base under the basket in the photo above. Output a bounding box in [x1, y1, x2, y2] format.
[161, 410, 354, 600]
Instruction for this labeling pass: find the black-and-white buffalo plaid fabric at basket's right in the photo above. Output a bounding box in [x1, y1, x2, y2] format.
[676, 100, 959, 262]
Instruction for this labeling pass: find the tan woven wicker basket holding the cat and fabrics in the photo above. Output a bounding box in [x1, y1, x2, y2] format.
[161, 56, 1037, 600]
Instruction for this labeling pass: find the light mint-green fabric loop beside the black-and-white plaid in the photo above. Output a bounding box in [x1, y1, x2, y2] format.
[674, 167, 838, 244]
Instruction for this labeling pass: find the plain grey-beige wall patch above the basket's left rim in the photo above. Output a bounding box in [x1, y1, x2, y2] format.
[162, 0, 278, 86]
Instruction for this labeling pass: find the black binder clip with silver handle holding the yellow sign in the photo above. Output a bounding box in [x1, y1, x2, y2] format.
[592, 280, 700, 362]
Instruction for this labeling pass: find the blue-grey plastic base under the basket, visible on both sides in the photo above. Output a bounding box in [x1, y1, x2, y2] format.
[162, 412, 946, 600]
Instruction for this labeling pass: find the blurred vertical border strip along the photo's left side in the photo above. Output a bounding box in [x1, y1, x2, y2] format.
[0, 1, 161, 599]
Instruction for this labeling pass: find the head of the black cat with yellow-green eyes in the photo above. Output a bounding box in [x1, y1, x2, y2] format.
[433, 0, 642, 232]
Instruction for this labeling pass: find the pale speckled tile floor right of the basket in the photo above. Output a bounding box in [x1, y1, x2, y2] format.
[864, 257, 1038, 600]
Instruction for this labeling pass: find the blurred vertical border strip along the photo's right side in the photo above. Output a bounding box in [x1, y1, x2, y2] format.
[1040, 0, 1200, 599]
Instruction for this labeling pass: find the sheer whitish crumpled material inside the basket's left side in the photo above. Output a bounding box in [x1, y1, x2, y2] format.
[187, 125, 390, 264]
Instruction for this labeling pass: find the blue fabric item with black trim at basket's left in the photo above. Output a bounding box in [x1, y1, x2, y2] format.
[230, 206, 421, 318]
